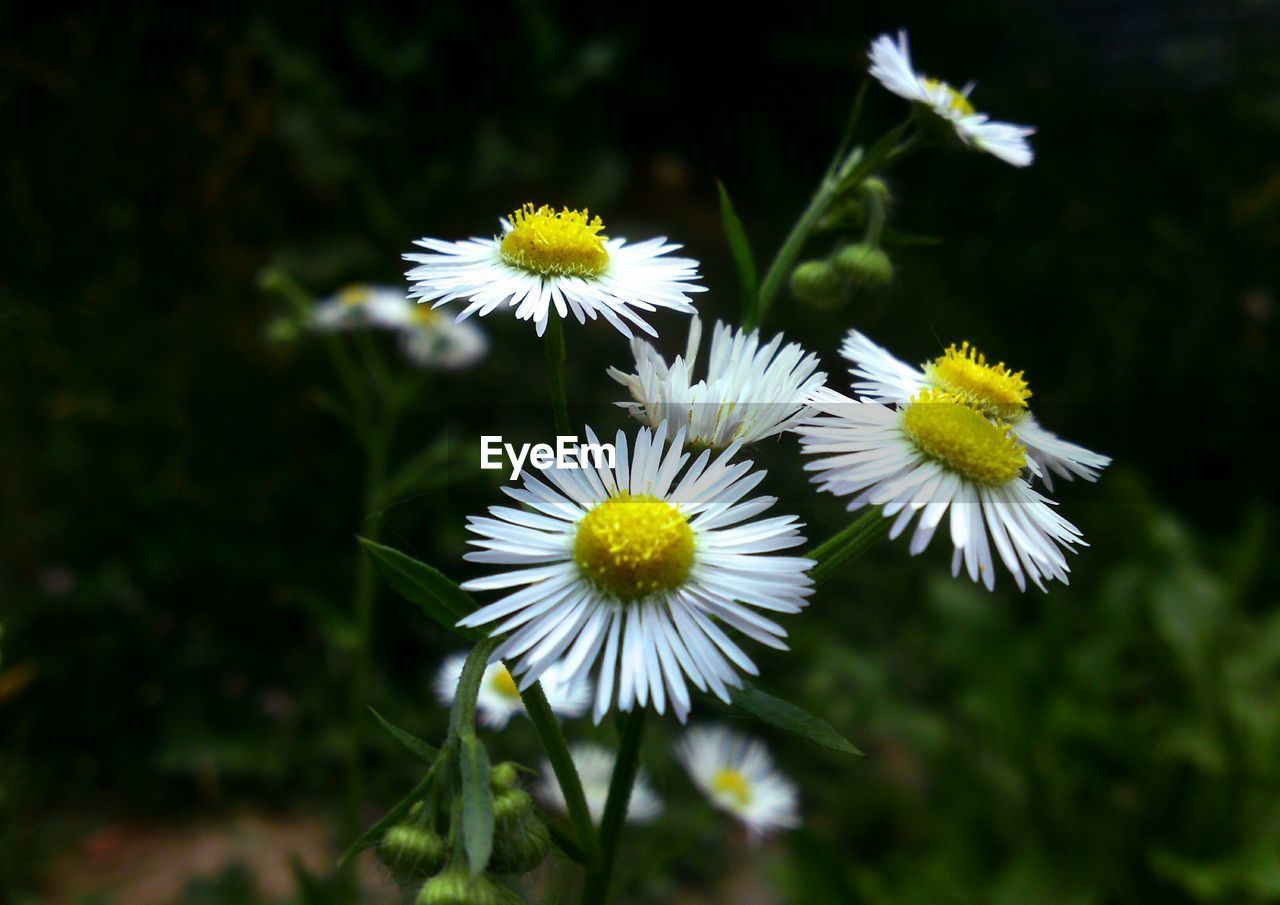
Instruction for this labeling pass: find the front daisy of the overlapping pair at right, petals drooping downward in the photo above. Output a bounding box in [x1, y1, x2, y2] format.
[796, 388, 1087, 590]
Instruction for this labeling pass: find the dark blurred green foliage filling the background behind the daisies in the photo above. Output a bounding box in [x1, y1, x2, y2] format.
[0, 0, 1280, 904]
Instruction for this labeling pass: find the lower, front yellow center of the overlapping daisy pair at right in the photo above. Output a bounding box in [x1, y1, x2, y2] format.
[902, 389, 1027, 484]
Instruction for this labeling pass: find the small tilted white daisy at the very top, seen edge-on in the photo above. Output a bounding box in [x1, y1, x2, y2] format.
[868, 31, 1036, 166]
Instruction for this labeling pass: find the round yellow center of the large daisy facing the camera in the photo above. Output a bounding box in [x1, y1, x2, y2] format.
[573, 493, 694, 602]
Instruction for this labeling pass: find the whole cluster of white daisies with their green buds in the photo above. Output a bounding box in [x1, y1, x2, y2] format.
[340, 26, 1110, 895]
